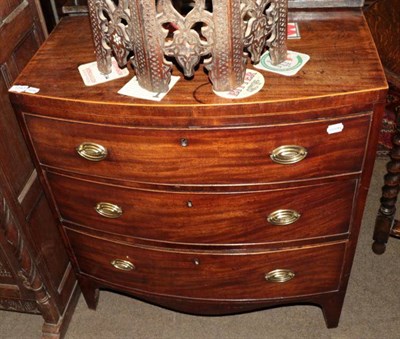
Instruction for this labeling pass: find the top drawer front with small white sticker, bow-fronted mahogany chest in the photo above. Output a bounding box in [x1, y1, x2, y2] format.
[25, 115, 370, 184]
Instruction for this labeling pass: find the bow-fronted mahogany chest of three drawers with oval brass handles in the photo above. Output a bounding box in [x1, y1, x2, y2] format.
[11, 10, 386, 327]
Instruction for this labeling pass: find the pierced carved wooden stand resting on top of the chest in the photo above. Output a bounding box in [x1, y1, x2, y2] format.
[88, 0, 287, 92]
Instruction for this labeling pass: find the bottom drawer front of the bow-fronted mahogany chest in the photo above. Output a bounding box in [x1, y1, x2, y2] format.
[67, 230, 346, 299]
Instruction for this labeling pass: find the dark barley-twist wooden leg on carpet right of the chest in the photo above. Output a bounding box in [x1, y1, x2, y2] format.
[372, 131, 400, 254]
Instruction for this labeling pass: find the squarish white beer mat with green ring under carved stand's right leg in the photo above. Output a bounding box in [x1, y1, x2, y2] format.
[254, 51, 310, 76]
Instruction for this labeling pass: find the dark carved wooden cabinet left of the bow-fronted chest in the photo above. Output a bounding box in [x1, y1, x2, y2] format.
[0, 0, 78, 338]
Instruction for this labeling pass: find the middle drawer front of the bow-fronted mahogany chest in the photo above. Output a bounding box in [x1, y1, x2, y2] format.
[48, 173, 356, 244]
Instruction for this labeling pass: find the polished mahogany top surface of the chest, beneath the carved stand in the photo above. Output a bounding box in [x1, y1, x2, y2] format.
[12, 9, 387, 124]
